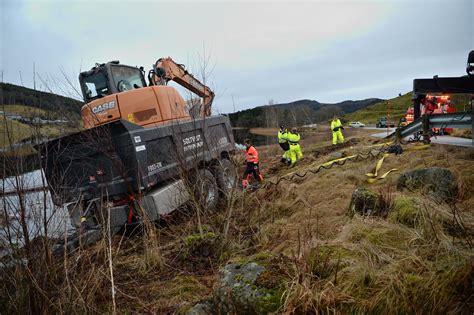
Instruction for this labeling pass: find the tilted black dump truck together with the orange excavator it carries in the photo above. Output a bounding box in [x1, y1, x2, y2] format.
[38, 57, 237, 249]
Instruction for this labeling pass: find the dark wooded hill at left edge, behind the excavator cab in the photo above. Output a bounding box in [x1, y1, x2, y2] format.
[0, 83, 84, 116]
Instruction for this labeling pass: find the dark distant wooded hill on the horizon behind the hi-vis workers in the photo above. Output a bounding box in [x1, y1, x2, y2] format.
[229, 99, 381, 128]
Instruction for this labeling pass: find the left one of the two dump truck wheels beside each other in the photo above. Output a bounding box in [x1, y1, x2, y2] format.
[191, 169, 219, 210]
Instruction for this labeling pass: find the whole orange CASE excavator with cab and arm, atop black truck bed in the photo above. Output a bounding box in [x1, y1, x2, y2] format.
[79, 57, 214, 128]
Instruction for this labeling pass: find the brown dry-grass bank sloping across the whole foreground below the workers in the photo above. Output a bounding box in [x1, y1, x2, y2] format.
[0, 129, 474, 314]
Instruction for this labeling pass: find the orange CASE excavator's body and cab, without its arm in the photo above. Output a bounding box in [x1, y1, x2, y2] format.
[79, 61, 190, 129]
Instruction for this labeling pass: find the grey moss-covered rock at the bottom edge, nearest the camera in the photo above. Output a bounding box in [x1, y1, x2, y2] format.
[214, 262, 280, 314]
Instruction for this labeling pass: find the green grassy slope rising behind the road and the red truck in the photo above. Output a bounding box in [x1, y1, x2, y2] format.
[344, 92, 469, 124]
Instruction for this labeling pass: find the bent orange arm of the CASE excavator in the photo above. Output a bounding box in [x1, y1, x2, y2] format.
[148, 57, 214, 117]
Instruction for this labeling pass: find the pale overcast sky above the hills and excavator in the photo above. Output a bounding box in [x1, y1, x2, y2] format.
[0, 0, 474, 113]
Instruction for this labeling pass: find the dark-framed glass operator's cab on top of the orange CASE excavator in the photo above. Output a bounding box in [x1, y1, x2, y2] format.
[79, 60, 147, 103]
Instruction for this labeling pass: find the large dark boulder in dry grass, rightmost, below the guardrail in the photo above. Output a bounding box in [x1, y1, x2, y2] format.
[397, 167, 458, 203]
